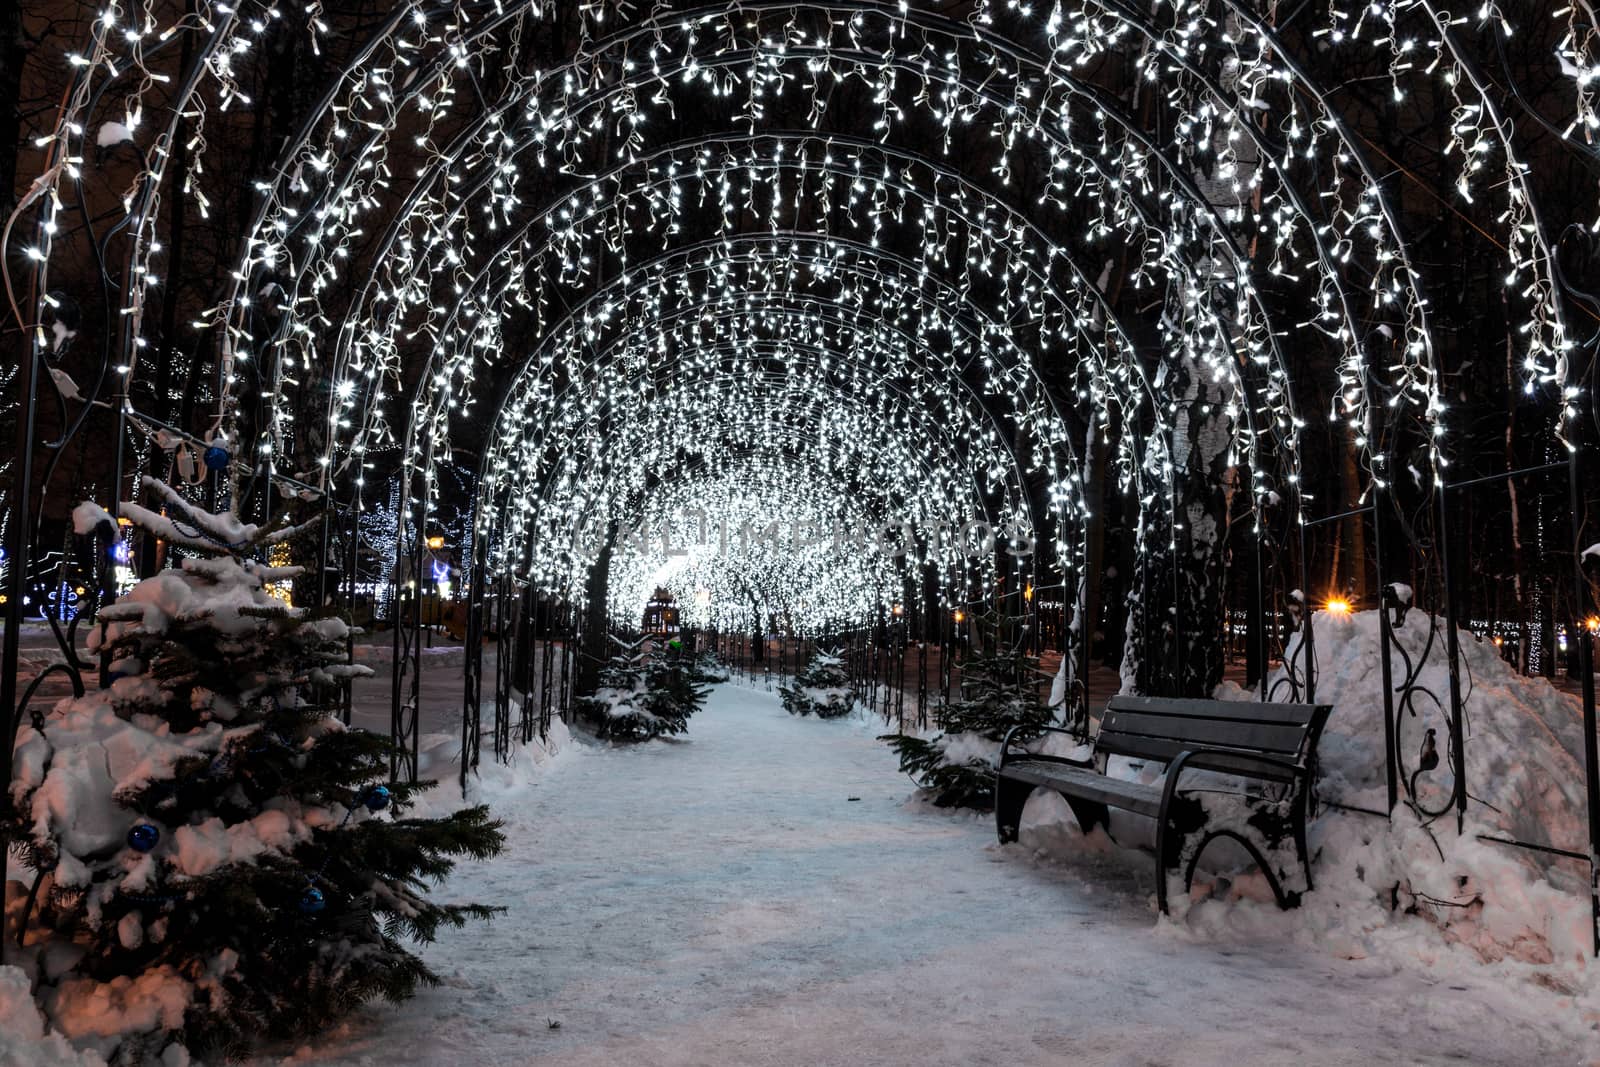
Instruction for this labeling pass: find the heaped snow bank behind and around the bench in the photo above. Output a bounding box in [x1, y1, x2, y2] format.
[1022, 611, 1600, 991]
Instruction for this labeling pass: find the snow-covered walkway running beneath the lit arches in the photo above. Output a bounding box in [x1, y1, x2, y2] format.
[268, 685, 1594, 1067]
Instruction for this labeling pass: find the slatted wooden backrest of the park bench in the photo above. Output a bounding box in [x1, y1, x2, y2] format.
[1094, 696, 1330, 781]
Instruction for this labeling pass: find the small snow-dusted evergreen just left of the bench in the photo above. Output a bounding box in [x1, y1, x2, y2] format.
[880, 624, 1051, 811]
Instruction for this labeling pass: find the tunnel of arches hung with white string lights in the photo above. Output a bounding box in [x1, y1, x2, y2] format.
[6, 0, 1600, 934]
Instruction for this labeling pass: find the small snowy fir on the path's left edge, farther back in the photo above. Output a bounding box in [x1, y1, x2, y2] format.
[578, 633, 709, 741]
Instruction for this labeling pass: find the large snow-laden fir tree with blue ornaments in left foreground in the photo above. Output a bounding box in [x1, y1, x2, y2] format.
[0, 478, 502, 1064]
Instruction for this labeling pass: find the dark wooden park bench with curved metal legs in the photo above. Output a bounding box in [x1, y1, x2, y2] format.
[995, 696, 1330, 913]
